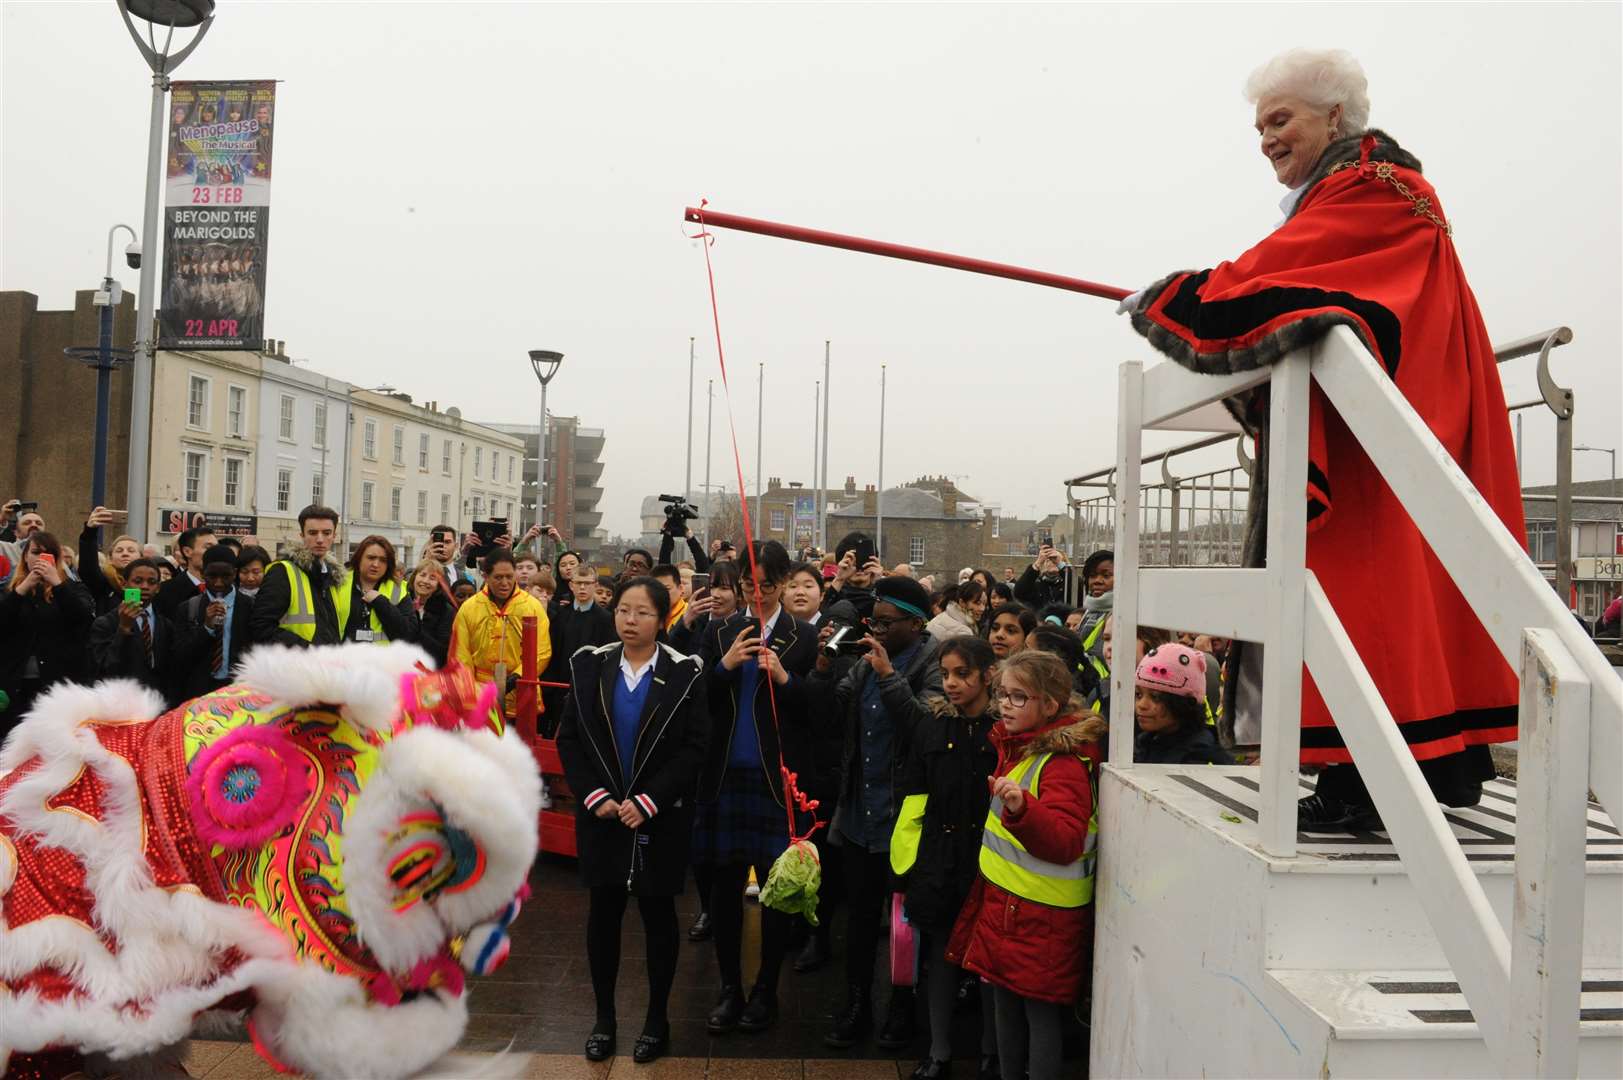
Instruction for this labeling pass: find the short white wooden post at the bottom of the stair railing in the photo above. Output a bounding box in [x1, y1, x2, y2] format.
[1503, 629, 1591, 1077]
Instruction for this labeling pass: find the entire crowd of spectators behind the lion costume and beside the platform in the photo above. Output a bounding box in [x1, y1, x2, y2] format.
[0, 493, 1227, 1080]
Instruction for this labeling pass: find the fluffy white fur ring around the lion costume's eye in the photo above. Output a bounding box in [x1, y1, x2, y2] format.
[344, 728, 540, 974]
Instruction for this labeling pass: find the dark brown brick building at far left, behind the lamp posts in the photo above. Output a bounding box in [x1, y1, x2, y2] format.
[0, 291, 135, 544]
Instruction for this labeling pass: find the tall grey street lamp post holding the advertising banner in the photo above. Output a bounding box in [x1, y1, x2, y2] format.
[118, 0, 214, 541]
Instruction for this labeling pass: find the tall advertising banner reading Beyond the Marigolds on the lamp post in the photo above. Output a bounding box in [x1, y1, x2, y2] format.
[157, 81, 276, 349]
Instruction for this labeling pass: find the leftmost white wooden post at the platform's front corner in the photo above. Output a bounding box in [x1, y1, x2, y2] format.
[1110, 361, 1144, 767]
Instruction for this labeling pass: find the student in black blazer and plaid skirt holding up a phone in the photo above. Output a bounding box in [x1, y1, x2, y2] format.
[693, 541, 816, 1035]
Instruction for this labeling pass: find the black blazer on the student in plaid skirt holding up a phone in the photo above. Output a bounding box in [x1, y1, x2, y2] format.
[700, 609, 816, 806]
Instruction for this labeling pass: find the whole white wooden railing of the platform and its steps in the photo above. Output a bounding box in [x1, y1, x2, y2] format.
[1110, 328, 1623, 1077]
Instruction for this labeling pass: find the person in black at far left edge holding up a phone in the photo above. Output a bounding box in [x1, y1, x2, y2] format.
[0, 529, 96, 741]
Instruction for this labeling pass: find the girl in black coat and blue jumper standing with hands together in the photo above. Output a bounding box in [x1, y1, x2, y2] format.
[558, 568, 709, 1064]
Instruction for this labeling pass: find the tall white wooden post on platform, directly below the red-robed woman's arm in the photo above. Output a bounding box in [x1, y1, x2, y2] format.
[1258, 346, 1316, 858]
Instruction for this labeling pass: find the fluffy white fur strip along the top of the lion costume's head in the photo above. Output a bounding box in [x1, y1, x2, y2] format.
[237, 642, 433, 731]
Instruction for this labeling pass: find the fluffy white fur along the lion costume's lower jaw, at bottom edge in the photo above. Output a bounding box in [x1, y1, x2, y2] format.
[253, 965, 467, 1077]
